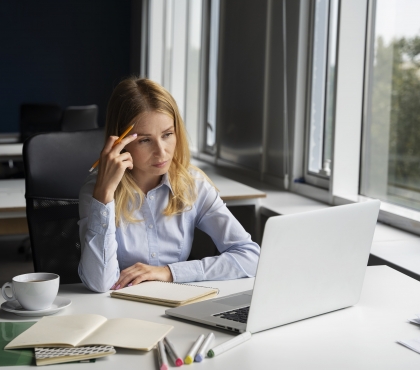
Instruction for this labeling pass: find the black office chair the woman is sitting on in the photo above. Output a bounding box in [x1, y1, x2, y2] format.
[23, 129, 104, 284]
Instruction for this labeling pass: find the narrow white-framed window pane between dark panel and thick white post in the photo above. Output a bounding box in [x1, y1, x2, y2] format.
[305, 0, 339, 187]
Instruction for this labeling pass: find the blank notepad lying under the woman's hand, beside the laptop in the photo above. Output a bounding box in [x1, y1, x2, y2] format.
[115, 281, 218, 302]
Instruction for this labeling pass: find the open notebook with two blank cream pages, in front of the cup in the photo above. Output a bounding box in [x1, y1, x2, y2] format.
[5, 314, 173, 351]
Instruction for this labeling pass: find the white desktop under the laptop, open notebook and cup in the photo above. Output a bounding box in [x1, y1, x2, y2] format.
[0, 266, 420, 370]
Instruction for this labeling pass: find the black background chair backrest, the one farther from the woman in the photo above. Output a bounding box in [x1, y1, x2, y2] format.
[20, 103, 63, 142]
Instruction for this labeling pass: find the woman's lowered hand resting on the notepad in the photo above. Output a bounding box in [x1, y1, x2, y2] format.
[111, 262, 173, 290]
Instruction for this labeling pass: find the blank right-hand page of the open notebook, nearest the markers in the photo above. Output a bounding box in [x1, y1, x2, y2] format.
[80, 318, 173, 351]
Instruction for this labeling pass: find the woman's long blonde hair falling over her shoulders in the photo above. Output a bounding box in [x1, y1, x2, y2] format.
[105, 77, 211, 226]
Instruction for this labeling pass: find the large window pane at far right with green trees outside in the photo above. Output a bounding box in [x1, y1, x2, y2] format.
[360, 0, 420, 210]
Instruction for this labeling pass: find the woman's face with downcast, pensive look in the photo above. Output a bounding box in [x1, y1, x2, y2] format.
[125, 112, 176, 191]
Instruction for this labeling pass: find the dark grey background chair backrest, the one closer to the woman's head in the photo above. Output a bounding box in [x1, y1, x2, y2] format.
[61, 104, 98, 131]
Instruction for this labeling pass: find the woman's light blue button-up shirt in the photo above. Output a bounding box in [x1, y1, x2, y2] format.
[79, 171, 260, 292]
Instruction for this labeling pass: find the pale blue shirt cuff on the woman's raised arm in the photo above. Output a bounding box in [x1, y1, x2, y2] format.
[87, 197, 116, 235]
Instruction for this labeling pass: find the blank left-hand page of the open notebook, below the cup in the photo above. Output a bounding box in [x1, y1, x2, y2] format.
[6, 314, 106, 348]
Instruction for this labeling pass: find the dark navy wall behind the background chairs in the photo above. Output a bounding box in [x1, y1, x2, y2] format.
[0, 0, 131, 132]
